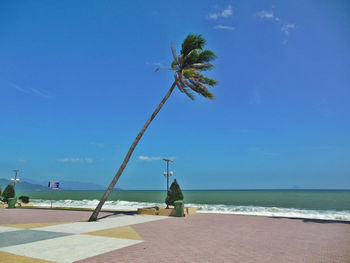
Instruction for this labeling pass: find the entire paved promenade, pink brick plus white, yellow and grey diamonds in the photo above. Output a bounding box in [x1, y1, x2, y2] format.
[0, 209, 350, 263]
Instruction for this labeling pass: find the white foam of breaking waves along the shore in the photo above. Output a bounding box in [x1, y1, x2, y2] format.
[32, 199, 350, 221]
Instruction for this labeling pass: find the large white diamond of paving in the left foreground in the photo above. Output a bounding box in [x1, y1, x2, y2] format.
[0, 235, 143, 263]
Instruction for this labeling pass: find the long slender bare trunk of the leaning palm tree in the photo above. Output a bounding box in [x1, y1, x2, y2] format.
[89, 80, 177, 222]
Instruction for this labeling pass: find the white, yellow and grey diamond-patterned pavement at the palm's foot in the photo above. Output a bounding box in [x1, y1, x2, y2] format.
[0, 215, 166, 263]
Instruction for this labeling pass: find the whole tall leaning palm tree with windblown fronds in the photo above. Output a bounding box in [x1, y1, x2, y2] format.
[89, 34, 217, 221]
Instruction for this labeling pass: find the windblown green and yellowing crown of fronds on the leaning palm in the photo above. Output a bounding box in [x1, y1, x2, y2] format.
[171, 34, 217, 100]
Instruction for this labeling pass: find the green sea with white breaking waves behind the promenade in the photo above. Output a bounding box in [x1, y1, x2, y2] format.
[17, 190, 350, 221]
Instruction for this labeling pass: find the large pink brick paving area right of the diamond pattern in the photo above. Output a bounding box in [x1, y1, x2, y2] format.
[80, 214, 350, 263]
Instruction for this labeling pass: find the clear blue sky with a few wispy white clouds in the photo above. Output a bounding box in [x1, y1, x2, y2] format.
[0, 1, 350, 189]
